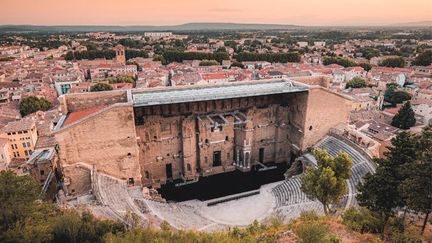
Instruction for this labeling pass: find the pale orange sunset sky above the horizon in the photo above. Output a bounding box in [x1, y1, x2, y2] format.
[0, 0, 432, 25]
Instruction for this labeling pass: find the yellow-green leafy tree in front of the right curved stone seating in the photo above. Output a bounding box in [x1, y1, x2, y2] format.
[301, 149, 352, 214]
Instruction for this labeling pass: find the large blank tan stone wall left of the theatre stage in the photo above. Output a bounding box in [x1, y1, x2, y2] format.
[55, 104, 141, 191]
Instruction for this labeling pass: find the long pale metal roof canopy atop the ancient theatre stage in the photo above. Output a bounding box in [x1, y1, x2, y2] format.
[132, 79, 309, 107]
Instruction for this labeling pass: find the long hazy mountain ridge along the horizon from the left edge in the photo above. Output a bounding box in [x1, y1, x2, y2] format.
[0, 23, 300, 32]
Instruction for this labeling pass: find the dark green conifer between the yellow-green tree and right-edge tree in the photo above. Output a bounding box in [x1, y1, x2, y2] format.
[356, 132, 417, 232]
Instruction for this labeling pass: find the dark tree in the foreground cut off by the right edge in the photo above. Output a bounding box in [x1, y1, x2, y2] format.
[400, 126, 432, 234]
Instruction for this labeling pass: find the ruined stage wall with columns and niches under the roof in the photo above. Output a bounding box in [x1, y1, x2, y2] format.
[135, 92, 308, 187]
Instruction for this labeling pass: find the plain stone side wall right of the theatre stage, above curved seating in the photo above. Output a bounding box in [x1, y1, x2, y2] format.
[303, 86, 352, 150]
